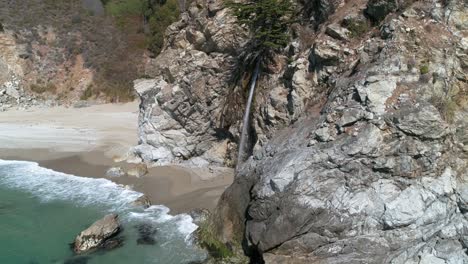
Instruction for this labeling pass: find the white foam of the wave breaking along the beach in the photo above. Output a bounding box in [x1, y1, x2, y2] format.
[0, 160, 197, 239]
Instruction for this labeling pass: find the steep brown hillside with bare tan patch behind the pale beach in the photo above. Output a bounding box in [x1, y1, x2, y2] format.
[0, 0, 144, 107]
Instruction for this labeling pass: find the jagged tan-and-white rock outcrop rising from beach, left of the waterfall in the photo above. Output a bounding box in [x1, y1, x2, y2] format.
[130, 1, 249, 165]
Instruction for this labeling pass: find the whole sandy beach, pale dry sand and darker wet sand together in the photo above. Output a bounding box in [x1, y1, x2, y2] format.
[0, 103, 233, 213]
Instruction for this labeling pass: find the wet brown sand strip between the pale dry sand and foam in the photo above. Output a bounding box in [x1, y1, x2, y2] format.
[0, 149, 233, 214]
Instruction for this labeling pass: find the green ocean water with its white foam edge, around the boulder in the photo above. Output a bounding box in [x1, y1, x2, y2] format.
[0, 160, 205, 264]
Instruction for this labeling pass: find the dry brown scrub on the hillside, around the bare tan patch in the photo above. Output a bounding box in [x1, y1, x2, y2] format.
[0, 0, 145, 101]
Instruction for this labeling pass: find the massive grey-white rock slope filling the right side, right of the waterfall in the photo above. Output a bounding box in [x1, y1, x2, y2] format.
[216, 0, 468, 264]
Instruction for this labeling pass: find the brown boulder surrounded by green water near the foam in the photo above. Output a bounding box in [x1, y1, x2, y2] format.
[73, 214, 120, 254]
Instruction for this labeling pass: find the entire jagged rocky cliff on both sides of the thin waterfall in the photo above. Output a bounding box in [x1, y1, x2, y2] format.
[135, 0, 468, 263]
